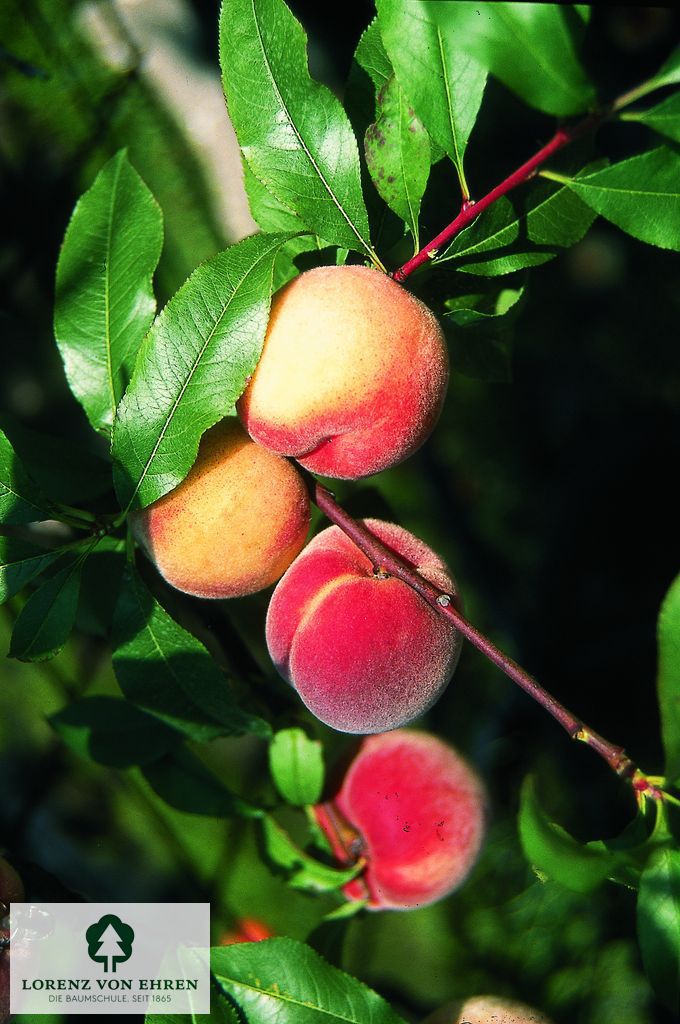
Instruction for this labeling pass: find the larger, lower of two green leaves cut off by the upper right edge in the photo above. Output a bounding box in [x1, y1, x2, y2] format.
[548, 146, 680, 252]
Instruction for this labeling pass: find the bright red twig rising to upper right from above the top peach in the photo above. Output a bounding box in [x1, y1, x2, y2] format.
[392, 111, 602, 284]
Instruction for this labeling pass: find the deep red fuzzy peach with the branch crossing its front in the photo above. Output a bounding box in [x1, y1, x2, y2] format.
[266, 519, 461, 734]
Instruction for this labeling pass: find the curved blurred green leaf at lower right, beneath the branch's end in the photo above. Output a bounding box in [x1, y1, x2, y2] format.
[519, 778, 617, 893]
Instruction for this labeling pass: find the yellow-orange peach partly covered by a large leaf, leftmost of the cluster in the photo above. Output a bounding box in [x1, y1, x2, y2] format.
[130, 419, 309, 598]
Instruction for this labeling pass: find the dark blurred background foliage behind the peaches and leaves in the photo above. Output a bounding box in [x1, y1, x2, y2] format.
[0, 0, 680, 1024]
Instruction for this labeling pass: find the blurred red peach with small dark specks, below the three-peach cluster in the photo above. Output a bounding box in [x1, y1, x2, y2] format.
[315, 729, 485, 910]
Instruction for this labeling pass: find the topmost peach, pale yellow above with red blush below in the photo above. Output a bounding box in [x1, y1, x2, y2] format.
[238, 266, 449, 479]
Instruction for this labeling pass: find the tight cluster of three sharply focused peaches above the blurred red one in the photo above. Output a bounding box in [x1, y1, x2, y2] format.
[131, 266, 461, 734]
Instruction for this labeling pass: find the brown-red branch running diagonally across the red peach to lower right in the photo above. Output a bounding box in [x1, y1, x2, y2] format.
[306, 474, 664, 800]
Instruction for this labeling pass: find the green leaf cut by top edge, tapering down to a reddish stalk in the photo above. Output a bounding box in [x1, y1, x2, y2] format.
[378, 0, 487, 195]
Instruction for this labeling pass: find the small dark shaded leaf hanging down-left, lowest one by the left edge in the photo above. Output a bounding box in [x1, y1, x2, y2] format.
[9, 555, 85, 662]
